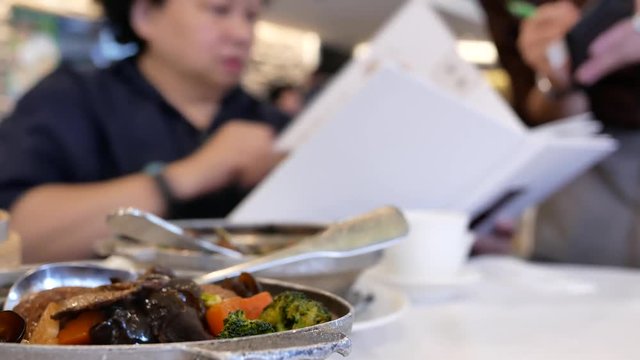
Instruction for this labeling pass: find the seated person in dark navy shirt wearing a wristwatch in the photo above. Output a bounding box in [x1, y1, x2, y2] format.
[0, 0, 287, 261]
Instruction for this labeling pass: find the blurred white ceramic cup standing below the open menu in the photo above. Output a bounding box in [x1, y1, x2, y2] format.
[380, 210, 473, 283]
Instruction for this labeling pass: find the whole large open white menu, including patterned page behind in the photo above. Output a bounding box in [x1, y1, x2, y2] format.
[229, 0, 617, 231]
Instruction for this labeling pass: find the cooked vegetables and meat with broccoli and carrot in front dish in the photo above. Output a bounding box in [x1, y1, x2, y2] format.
[16, 272, 331, 345]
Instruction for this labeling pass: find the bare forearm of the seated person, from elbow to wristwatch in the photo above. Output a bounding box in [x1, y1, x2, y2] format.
[11, 175, 165, 263]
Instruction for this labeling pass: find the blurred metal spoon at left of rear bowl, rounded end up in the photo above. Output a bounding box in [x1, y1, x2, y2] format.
[107, 208, 243, 259]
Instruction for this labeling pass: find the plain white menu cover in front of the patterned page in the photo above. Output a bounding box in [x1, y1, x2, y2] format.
[229, 62, 616, 229]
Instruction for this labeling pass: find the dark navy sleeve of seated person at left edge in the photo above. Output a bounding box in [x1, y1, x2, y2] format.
[0, 67, 98, 208]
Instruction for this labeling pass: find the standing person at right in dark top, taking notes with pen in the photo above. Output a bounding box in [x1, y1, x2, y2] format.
[481, 0, 640, 267]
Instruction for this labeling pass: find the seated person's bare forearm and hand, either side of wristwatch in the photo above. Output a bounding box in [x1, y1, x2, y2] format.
[11, 121, 275, 262]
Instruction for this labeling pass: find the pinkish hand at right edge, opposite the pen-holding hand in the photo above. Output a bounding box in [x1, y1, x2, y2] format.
[576, 15, 640, 85]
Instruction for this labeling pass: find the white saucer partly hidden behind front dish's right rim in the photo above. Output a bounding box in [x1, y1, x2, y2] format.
[351, 281, 409, 332]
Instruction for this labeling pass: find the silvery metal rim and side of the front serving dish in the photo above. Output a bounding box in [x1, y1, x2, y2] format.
[0, 278, 353, 360]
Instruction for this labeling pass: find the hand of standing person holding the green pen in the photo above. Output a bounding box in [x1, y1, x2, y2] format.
[517, 1, 580, 88]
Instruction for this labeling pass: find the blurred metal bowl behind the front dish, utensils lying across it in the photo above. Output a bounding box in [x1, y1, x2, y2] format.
[97, 220, 382, 296]
